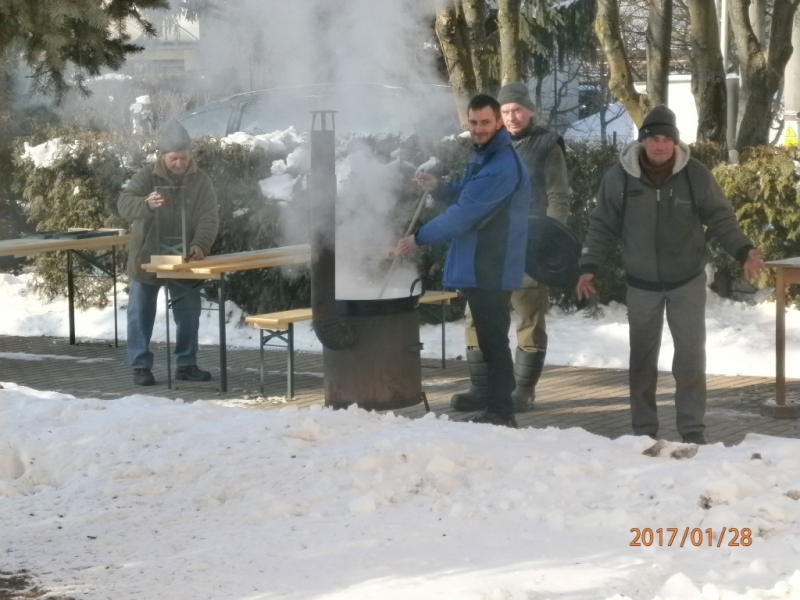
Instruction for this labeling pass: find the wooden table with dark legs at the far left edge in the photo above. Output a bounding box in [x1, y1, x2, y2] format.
[0, 230, 131, 347]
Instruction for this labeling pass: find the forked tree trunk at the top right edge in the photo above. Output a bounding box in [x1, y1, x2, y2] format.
[730, 0, 800, 151]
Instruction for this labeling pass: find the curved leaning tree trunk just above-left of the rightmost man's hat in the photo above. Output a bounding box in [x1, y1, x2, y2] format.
[594, 0, 651, 126]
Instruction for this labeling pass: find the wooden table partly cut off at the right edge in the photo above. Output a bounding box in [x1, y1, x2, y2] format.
[761, 257, 800, 419]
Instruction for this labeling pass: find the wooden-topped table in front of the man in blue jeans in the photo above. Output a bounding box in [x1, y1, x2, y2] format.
[142, 244, 311, 392]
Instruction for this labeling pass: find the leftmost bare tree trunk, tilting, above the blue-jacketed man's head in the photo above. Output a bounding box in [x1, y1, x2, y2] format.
[435, 0, 477, 129]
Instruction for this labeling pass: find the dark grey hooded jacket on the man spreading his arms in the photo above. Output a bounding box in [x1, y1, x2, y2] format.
[580, 142, 753, 290]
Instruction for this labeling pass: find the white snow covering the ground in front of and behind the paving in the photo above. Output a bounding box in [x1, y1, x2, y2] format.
[0, 275, 800, 600]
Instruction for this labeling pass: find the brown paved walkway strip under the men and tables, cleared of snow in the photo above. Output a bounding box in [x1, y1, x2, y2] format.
[0, 336, 800, 444]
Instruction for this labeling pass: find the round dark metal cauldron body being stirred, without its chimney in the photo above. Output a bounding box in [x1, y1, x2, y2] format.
[322, 280, 422, 410]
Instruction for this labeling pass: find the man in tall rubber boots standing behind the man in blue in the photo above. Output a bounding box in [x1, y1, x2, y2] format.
[450, 82, 570, 413]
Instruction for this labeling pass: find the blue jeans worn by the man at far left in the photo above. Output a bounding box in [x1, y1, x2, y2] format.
[128, 280, 201, 369]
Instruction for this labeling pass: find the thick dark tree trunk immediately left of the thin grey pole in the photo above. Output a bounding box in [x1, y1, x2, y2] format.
[688, 0, 728, 144]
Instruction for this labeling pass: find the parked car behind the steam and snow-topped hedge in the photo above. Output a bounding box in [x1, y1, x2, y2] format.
[177, 83, 460, 137]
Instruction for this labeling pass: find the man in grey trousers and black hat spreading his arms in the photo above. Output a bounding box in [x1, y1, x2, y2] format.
[577, 106, 764, 444]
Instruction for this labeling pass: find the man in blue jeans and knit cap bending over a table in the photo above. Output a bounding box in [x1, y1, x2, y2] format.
[117, 121, 219, 385]
